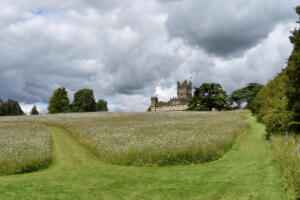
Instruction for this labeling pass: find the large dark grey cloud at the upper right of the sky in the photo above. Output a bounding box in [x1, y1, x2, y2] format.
[166, 0, 296, 56]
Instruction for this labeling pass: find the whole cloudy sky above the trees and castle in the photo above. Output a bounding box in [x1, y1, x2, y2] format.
[0, 0, 297, 113]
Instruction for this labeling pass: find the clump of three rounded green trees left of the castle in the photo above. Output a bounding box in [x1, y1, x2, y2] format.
[48, 88, 108, 114]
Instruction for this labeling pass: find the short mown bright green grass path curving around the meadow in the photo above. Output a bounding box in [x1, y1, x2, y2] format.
[0, 117, 284, 200]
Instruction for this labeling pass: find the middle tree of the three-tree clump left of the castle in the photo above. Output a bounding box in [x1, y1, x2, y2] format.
[72, 89, 96, 112]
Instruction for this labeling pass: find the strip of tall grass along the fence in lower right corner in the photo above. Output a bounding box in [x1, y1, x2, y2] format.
[272, 136, 300, 200]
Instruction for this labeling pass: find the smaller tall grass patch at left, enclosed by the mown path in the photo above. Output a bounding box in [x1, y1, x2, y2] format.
[0, 121, 51, 175]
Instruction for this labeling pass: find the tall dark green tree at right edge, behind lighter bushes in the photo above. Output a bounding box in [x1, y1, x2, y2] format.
[286, 6, 300, 132]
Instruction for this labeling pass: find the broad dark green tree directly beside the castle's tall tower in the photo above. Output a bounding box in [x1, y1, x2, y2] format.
[189, 83, 228, 111]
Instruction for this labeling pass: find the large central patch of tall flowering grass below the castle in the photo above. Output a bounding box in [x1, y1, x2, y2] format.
[41, 112, 248, 166]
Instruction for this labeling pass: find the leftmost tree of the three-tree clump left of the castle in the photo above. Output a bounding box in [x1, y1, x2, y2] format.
[48, 88, 70, 114]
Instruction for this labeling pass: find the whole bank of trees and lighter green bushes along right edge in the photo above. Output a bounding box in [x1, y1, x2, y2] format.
[253, 6, 300, 137]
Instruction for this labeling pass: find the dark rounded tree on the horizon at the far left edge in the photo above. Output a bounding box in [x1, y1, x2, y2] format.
[0, 99, 24, 116]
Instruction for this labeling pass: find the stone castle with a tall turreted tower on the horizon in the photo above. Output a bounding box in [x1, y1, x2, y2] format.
[151, 80, 192, 112]
